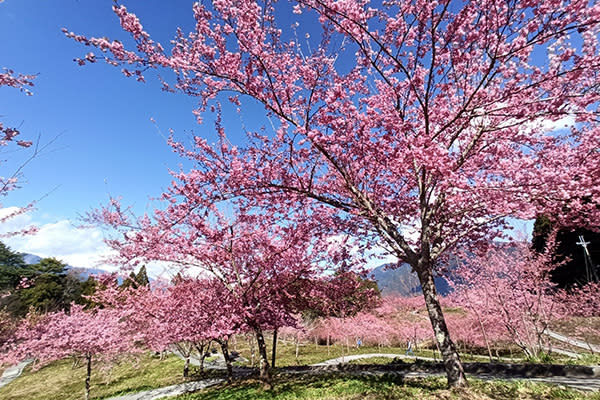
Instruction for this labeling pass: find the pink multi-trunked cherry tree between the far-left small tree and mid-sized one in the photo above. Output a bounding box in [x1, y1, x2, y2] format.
[113, 277, 242, 377]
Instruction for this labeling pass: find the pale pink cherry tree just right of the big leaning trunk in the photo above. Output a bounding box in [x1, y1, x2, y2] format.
[455, 242, 568, 357]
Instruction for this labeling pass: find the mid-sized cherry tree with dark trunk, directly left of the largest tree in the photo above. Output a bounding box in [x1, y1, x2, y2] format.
[90, 202, 352, 388]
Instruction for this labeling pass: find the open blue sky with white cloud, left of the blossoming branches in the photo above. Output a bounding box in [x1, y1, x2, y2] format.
[0, 0, 225, 266]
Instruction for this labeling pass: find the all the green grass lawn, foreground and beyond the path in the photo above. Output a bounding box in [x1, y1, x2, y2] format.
[0, 343, 600, 400]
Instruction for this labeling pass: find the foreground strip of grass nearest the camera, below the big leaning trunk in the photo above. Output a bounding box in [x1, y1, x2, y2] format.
[174, 375, 600, 400]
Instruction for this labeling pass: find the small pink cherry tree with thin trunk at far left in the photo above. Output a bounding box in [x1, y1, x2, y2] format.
[4, 304, 137, 400]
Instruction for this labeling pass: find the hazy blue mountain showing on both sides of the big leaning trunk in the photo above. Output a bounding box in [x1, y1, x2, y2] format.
[372, 264, 450, 297]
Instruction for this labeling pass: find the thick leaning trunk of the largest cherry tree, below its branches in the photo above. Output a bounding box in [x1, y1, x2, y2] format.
[415, 266, 467, 387]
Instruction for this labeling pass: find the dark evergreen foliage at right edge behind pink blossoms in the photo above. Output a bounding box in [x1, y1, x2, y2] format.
[532, 216, 600, 288]
